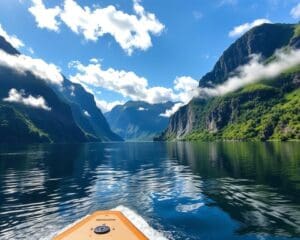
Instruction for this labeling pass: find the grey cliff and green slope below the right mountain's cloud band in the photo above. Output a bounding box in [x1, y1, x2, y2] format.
[157, 72, 300, 141]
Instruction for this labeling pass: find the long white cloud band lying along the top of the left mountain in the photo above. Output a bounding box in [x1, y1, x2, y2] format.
[0, 50, 63, 84]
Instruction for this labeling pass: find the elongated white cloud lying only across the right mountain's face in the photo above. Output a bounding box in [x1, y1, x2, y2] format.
[198, 50, 300, 97]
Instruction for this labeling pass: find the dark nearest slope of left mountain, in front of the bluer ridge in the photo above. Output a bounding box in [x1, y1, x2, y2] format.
[0, 63, 86, 142]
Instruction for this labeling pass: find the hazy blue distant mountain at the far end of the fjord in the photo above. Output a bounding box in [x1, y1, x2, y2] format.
[105, 101, 174, 141]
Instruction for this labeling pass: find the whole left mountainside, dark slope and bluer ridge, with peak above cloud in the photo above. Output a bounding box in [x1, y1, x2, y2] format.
[0, 37, 122, 143]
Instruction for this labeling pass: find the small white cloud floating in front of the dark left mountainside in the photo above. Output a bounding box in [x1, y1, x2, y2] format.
[3, 88, 51, 111]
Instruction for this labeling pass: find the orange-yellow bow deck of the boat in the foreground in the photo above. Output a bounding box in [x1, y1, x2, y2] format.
[53, 211, 148, 240]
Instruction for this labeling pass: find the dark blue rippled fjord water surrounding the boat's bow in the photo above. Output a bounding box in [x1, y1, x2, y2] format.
[0, 142, 300, 240]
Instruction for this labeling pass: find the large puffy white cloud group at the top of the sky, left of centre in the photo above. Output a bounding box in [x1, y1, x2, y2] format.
[29, 0, 164, 55]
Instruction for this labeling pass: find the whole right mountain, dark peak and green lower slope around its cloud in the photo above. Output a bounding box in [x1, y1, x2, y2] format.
[156, 24, 300, 140]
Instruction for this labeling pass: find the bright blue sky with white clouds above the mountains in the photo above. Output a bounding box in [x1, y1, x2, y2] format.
[0, 0, 300, 110]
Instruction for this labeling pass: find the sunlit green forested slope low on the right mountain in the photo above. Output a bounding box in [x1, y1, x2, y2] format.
[184, 75, 300, 140]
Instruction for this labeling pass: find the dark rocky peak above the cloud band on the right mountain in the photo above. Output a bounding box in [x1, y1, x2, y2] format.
[199, 24, 295, 87]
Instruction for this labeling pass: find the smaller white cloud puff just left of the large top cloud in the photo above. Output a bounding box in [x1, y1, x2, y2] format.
[28, 0, 61, 32]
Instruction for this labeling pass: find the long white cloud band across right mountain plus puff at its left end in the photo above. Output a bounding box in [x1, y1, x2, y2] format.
[161, 47, 300, 117]
